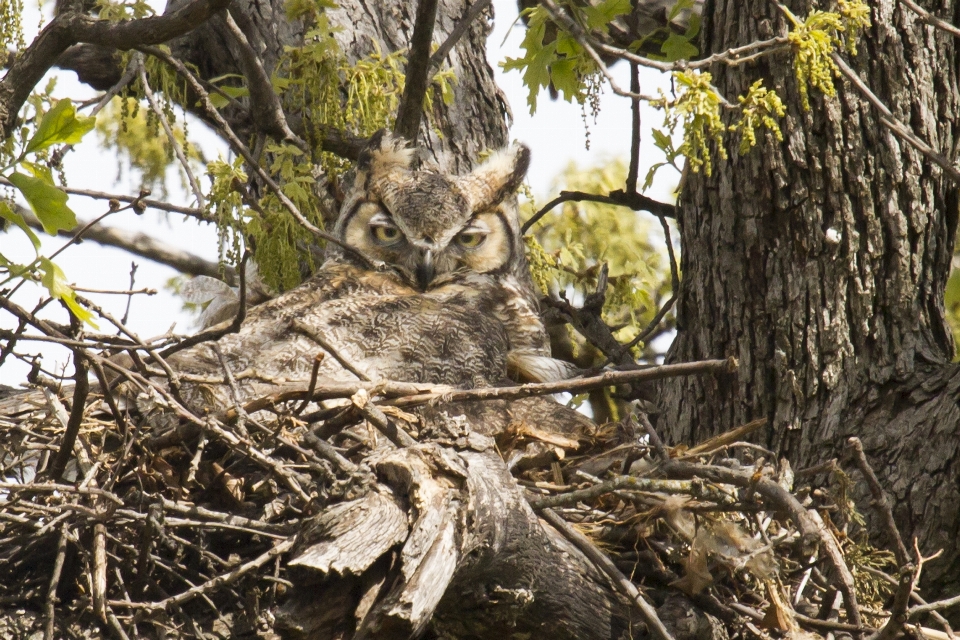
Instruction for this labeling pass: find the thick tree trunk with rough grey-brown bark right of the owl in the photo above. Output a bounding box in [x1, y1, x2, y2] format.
[659, 0, 960, 591]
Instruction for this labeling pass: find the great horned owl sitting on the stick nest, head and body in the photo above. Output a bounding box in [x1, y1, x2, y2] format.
[160, 134, 566, 418]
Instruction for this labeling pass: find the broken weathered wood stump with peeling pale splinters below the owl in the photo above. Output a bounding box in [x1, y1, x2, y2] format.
[280, 437, 635, 640]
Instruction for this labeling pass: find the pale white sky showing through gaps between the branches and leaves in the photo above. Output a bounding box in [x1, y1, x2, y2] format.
[0, 0, 677, 385]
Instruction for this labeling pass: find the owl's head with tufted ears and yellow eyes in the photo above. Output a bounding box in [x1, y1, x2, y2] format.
[336, 132, 530, 291]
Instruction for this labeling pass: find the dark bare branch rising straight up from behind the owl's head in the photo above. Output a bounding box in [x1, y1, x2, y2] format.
[393, 0, 438, 142]
